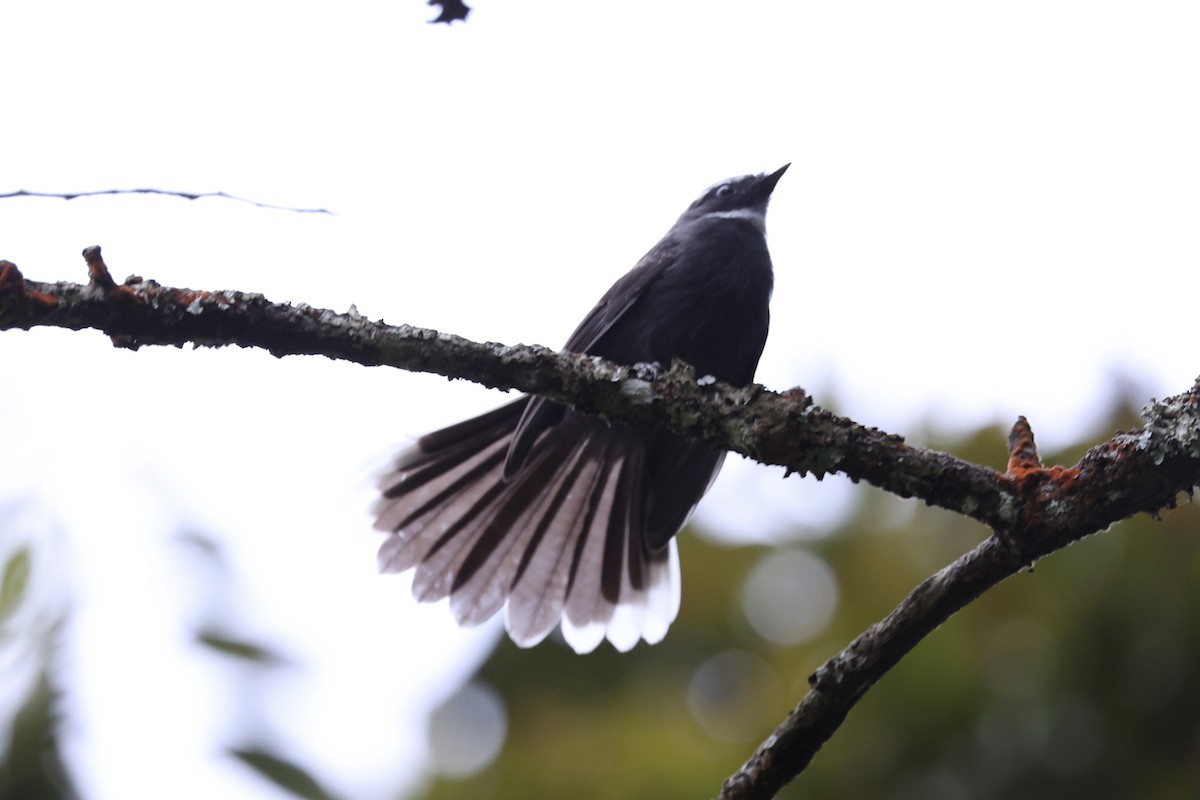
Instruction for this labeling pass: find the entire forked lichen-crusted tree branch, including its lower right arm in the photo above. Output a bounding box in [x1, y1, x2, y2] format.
[0, 247, 1200, 800]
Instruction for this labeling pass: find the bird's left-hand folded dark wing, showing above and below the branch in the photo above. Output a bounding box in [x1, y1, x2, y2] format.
[504, 234, 679, 481]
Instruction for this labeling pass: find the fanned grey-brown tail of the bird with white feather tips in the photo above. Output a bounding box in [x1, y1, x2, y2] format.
[374, 398, 679, 652]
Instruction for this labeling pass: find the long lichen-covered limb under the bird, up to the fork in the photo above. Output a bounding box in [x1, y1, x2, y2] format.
[0, 247, 1010, 523]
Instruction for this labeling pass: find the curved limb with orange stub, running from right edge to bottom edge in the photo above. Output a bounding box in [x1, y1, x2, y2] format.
[719, 402, 1200, 800]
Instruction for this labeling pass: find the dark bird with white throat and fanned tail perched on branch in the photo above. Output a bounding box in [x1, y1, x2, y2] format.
[372, 164, 790, 654]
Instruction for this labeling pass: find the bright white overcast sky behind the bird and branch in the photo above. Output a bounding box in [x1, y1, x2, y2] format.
[0, 0, 1200, 799]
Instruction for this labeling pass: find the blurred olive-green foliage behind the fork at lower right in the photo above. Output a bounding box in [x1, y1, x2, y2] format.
[422, 409, 1200, 800]
